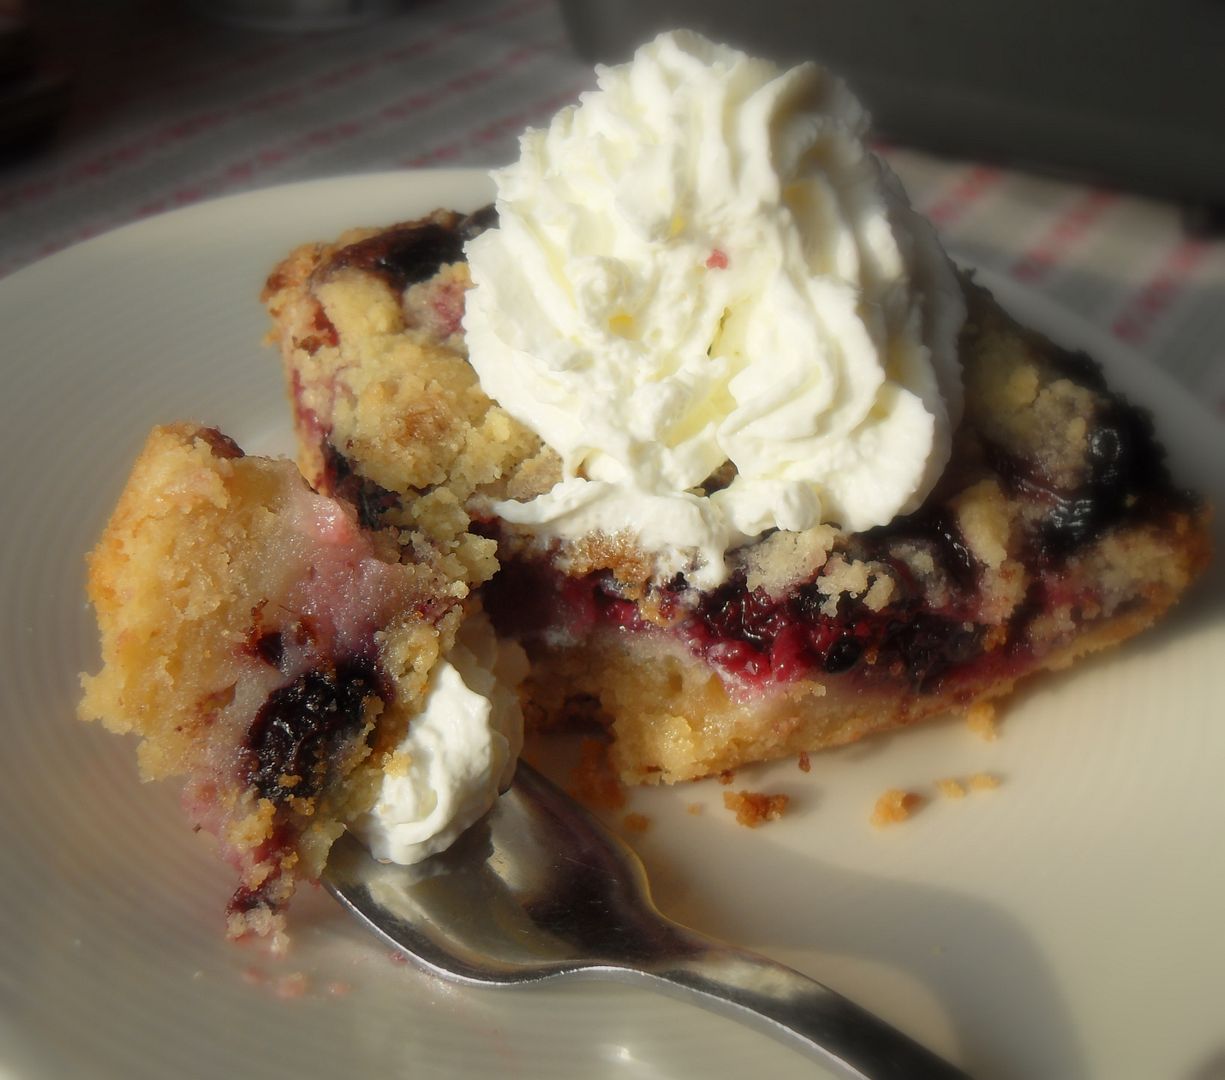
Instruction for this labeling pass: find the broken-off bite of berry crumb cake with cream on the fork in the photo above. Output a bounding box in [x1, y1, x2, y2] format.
[81, 424, 521, 940]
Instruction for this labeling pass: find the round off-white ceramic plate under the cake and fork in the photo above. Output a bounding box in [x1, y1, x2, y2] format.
[0, 171, 1225, 1080]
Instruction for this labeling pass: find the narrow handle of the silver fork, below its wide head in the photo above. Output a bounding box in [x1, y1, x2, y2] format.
[635, 931, 969, 1080]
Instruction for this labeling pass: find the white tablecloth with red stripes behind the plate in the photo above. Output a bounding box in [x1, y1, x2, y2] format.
[0, 0, 1225, 421]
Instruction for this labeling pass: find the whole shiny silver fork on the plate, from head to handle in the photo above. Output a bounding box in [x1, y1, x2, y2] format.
[323, 762, 967, 1080]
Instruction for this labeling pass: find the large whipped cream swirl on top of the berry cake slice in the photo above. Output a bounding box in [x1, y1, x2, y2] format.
[464, 32, 964, 588]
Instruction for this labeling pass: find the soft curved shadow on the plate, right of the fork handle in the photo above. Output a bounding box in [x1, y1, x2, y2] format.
[648, 836, 1082, 1080]
